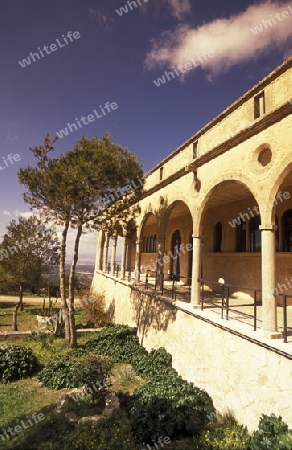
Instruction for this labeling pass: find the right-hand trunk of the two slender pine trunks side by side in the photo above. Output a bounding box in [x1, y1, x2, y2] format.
[69, 225, 82, 348]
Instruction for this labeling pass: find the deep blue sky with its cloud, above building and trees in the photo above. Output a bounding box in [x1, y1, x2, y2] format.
[0, 0, 292, 259]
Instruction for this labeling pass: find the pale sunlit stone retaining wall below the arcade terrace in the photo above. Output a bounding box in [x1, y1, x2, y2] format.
[93, 273, 292, 430]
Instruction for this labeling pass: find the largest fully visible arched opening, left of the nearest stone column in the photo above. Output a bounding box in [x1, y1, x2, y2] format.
[194, 179, 261, 289]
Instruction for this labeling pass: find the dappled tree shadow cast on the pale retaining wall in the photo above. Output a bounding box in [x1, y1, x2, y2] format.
[131, 289, 177, 345]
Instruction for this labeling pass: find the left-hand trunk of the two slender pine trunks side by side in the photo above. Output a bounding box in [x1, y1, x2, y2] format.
[60, 220, 71, 347]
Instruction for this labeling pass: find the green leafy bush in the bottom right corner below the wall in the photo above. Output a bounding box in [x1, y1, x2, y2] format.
[250, 414, 292, 450]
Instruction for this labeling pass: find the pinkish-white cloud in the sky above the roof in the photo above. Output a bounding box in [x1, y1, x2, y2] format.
[145, 1, 292, 76]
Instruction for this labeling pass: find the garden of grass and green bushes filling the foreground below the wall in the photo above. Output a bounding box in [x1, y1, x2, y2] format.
[0, 326, 292, 450]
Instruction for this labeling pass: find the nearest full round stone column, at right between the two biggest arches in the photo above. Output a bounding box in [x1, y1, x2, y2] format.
[260, 225, 282, 339]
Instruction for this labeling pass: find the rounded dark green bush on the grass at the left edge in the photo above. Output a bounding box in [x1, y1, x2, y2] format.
[0, 345, 39, 383]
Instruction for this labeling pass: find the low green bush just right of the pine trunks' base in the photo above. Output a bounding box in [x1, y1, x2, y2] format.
[85, 325, 147, 364]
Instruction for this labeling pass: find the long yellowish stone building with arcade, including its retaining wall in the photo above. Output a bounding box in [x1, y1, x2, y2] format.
[93, 57, 292, 428]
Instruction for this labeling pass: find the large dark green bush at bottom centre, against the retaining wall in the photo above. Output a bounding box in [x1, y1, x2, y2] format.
[124, 376, 214, 441]
